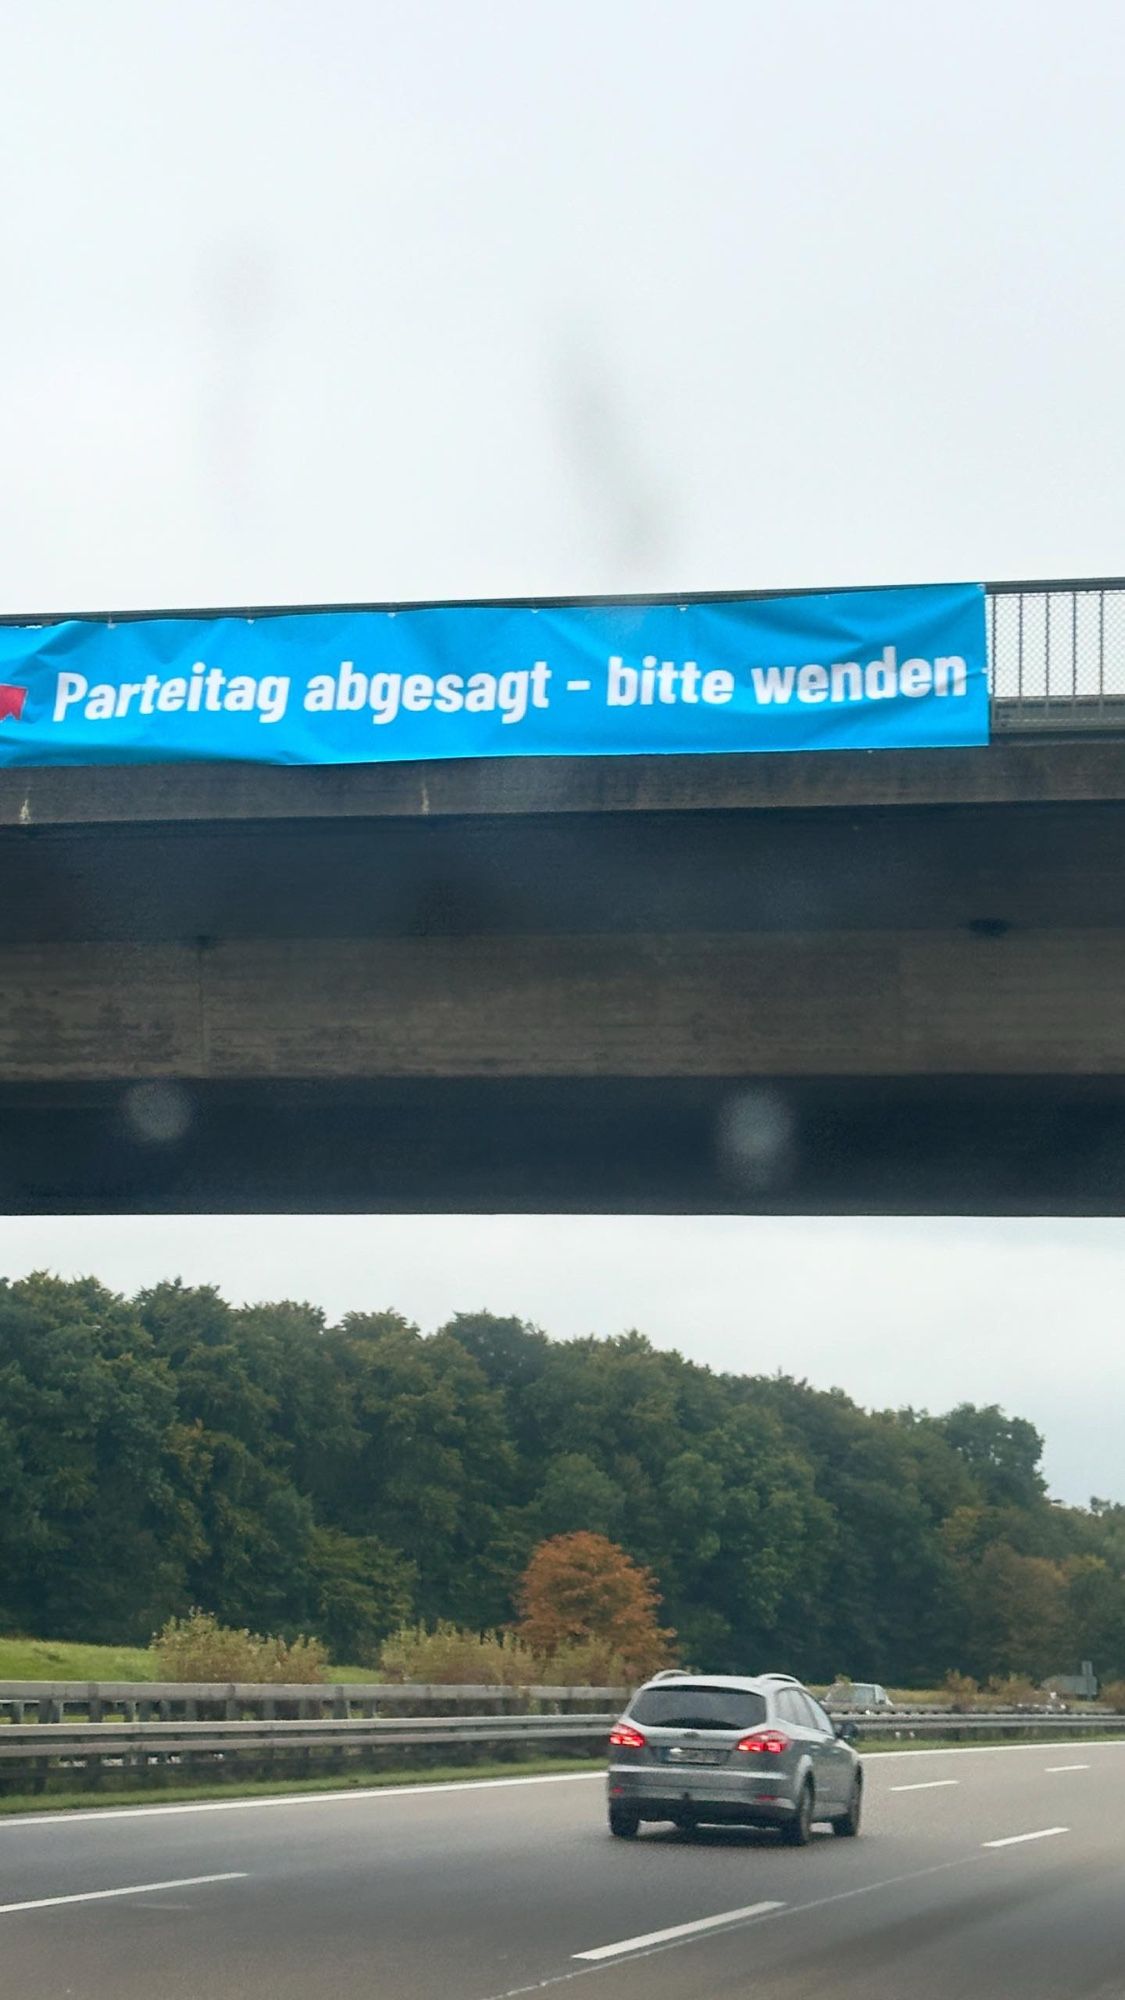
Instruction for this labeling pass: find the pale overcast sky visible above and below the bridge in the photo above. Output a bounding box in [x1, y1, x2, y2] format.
[0, 0, 1125, 1498]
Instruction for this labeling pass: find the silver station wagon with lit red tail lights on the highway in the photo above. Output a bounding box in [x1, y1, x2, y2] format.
[609, 1674, 863, 1846]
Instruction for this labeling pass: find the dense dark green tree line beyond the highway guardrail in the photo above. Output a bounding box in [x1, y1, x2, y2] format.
[0, 1274, 1125, 1686]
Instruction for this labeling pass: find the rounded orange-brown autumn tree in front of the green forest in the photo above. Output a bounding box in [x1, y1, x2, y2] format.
[516, 1532, 675, 1680]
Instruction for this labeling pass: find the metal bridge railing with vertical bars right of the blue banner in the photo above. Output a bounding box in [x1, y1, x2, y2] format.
[987, 576, 1125, 732]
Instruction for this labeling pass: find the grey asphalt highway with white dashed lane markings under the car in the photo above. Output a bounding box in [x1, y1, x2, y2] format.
[0, 1742, 1125, 2000]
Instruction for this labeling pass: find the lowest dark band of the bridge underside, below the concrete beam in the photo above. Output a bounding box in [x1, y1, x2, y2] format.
[0, 1078, 1125, 1216]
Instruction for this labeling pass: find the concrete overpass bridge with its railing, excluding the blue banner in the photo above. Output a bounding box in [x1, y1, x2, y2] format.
[0, 582, 1125, 1214]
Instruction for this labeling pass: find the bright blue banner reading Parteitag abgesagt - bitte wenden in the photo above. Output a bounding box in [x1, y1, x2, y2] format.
[0, 584, 989, 764]
